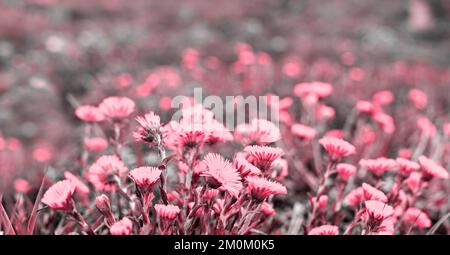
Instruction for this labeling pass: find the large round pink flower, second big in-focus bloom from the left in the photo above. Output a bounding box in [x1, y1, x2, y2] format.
[86, 155, 128, 190]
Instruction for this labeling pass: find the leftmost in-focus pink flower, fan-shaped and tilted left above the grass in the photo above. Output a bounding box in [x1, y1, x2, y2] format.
[41, 180, 75, 211]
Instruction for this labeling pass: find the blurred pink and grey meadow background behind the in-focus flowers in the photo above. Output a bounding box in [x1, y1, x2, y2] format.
[0, 0, 450, 191]
